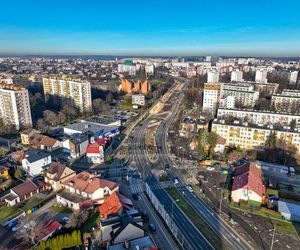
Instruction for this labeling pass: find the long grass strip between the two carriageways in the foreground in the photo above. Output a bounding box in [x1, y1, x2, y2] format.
[166, 188, 228, 249]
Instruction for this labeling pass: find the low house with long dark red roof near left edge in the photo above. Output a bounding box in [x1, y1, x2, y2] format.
[4, 180, 45, 206]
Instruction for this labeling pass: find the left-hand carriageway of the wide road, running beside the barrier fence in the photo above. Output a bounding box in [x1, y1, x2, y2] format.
[129, 82, 214, 250]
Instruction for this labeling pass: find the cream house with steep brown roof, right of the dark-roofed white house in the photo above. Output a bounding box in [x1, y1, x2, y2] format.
[45, 162, 76, 192]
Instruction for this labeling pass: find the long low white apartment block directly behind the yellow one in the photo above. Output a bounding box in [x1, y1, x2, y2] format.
[217, 108, 300, 126]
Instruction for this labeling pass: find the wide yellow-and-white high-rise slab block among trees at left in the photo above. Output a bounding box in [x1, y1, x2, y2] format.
[43, 78, 92, 112]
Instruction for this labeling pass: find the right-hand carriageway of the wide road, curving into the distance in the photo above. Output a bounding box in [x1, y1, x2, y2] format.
[155, 84, 251, 250]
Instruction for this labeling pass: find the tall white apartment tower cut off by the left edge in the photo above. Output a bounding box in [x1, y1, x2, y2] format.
[0, 83, 32, 129]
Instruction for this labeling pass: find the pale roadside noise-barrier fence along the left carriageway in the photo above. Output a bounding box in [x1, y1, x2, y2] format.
[146, 183, 194, 250]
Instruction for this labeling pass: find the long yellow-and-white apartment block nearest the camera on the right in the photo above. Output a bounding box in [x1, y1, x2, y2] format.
[212, 119, 300, 152]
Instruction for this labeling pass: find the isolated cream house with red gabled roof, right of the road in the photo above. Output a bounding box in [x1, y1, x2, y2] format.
[231, 162, 266, 203]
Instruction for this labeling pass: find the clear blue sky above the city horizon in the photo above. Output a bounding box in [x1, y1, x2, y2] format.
[0, 0, 300, 56]
